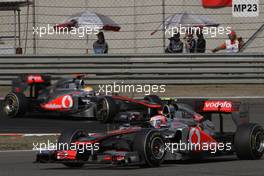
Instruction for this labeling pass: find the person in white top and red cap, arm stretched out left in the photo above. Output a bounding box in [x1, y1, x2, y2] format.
[212, 31, 244, 53]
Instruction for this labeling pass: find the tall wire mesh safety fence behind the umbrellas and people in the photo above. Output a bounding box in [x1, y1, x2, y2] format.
[0, 0, 264, 54]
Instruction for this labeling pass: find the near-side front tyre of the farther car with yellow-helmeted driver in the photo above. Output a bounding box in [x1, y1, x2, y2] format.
[96, 97, 117, 123]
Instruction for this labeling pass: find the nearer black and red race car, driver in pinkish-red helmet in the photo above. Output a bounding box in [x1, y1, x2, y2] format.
[36, 99, 264, 167]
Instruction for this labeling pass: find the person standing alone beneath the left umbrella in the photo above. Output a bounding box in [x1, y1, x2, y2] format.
[93, 32, 108, 54]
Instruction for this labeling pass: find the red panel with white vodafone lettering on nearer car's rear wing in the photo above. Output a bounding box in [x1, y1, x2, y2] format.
[203, 100, 232, 112]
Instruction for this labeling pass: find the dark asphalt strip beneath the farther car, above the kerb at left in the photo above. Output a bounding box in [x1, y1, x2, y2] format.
[0, 113, 107, 133]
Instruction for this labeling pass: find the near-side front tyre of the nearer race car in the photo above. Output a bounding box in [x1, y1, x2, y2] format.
[133, 129, 166, 167]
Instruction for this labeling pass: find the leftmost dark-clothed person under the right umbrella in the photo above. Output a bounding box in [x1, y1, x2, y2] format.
[165, 33, 183, 53]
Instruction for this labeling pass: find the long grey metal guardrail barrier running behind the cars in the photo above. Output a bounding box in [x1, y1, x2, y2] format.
[0, 53, 264, 85]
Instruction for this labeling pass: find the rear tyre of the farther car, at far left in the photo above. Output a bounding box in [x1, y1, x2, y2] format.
[2, 92, 28, 118]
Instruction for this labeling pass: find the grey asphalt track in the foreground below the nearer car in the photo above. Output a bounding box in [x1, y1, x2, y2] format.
[0, 152, 264, 176]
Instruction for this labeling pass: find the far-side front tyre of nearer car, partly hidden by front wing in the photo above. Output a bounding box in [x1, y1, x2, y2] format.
[57, 129, 89, 168]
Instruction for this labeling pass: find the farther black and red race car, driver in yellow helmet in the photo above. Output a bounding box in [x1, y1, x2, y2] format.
[2, 75, 161, 120]
